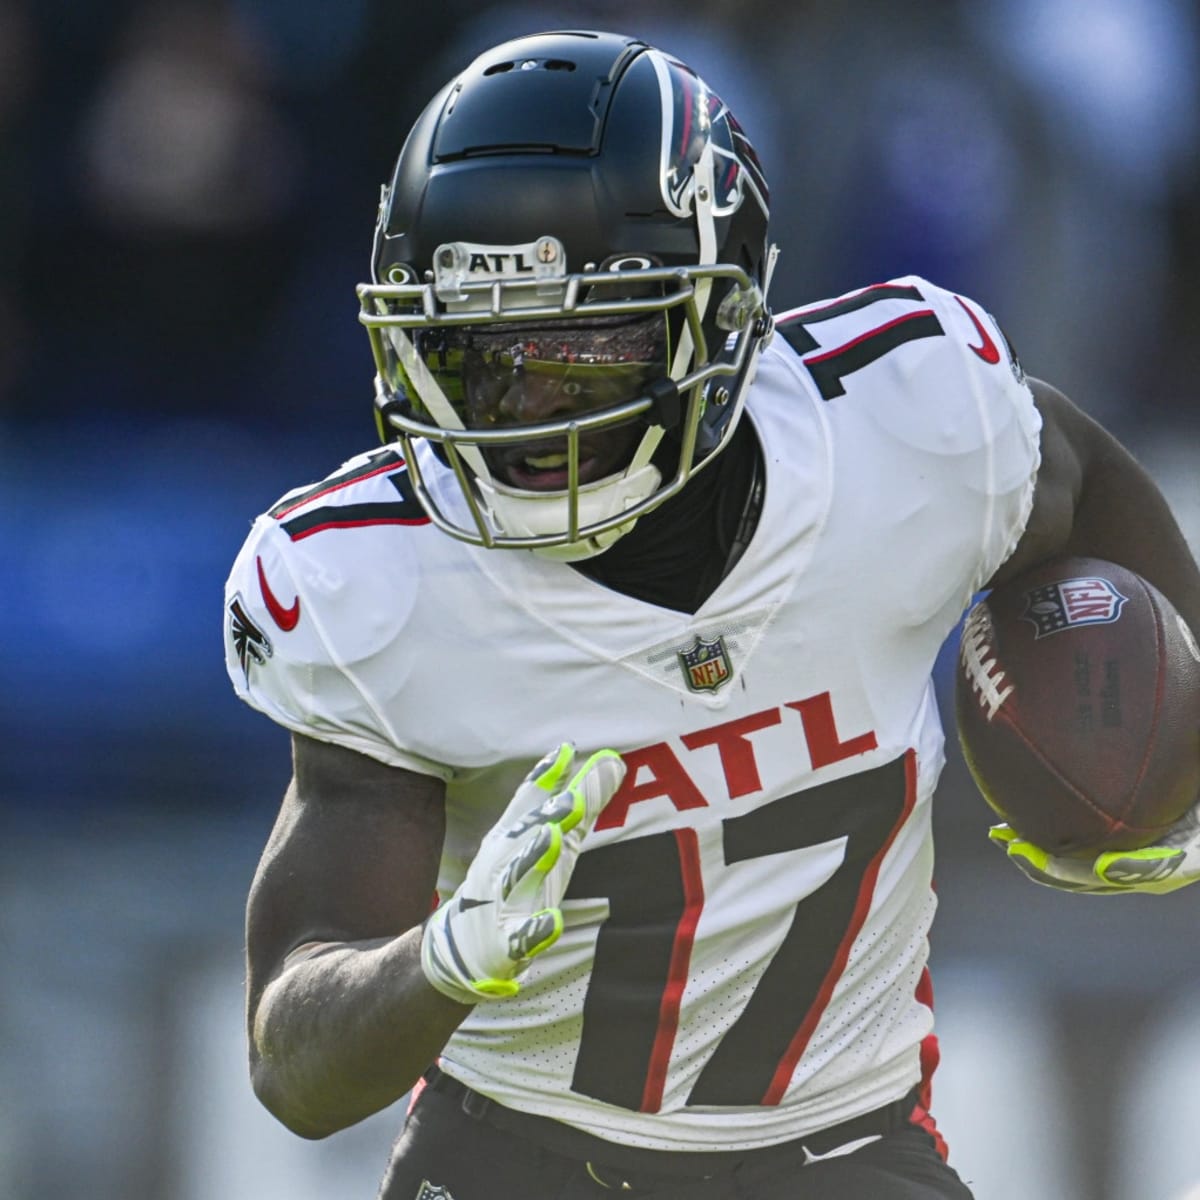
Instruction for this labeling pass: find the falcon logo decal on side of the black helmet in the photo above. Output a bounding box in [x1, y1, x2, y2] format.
[650, 52, 768, 217]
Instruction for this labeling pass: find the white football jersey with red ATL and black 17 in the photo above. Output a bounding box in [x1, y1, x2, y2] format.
[227, 277, 1040, 1150]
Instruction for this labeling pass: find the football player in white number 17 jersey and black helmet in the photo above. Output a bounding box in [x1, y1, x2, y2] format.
[227, 32, 1200, 1200]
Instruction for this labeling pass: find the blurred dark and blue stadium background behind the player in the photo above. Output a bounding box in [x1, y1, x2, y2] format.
[0, 0, 1200, 1200]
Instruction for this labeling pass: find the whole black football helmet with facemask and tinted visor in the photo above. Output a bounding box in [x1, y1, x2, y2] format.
[358, 31, 775, 559]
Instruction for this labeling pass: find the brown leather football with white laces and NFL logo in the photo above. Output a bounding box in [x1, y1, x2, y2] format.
[955, 558, 1200, 857]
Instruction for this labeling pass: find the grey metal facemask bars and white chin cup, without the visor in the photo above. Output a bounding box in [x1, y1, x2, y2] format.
[358, 236, 769, 559]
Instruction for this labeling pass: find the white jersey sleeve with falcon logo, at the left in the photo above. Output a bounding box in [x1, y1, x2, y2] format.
[224, 515, 454, 779]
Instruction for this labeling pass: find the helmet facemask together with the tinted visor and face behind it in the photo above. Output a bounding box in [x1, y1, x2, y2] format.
[359, 239, 762, 559]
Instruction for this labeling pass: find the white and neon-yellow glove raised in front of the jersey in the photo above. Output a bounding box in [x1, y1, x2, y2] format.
[421, 743, 625, 1004]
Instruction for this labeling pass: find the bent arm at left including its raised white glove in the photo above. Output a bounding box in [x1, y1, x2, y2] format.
[246, 737, 625, 1138]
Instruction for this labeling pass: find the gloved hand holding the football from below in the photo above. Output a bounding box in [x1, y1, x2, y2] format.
[988, 803, 1200, 895]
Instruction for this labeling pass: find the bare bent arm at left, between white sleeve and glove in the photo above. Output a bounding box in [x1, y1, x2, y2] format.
[246, 734, 470, 1138]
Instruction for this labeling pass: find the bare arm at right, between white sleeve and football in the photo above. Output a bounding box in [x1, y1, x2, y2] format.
[989, 379, 1200, 632]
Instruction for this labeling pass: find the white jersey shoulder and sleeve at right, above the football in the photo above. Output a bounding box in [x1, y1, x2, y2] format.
[779, 276, 1042, 628]
